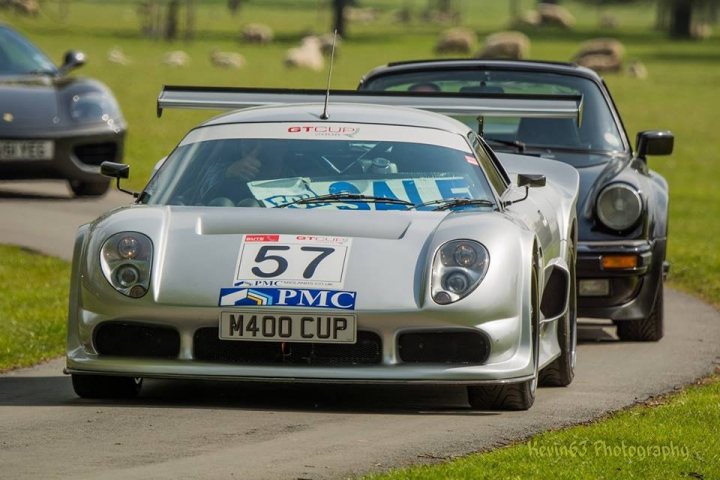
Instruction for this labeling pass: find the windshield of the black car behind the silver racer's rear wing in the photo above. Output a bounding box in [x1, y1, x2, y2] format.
[361, 69, 627, 163]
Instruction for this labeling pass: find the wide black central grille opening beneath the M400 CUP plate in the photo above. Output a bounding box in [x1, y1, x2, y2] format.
[193, 327, 382, 366]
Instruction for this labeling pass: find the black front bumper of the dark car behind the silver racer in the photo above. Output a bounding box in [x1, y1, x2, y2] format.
[577, 239, 666, 320]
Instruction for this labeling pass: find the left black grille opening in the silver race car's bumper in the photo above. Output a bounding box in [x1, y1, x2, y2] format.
[94, 322, 180, 358]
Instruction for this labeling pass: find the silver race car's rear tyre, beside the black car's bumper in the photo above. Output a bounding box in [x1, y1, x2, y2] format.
[540, 245, 577, 387]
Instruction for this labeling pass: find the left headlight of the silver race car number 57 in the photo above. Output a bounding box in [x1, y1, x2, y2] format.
[100, 232, 152, 298]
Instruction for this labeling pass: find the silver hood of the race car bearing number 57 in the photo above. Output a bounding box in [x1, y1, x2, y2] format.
[99, 206, 450, 310]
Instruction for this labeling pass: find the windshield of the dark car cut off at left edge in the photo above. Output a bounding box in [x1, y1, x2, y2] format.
[0, 26, 57, 76]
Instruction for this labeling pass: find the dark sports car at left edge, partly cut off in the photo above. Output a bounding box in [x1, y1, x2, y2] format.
[0, 24, 126, 196]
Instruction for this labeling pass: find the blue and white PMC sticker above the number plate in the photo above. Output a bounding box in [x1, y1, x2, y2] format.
[218, 287, 357, 310]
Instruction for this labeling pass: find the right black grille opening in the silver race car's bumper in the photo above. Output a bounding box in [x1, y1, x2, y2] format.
[398, 332, 490, 364]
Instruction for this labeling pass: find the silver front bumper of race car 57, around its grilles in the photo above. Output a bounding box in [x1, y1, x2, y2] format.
[66, 308, 533, 384]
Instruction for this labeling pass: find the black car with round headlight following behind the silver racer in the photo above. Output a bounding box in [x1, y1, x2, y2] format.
[358, 60, 673, 341]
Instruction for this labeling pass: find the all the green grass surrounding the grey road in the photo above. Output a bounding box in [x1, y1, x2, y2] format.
[0, 0, 720, 478]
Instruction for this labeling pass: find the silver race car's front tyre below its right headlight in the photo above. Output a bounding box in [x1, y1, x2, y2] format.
[468, 262, 540, 410]
